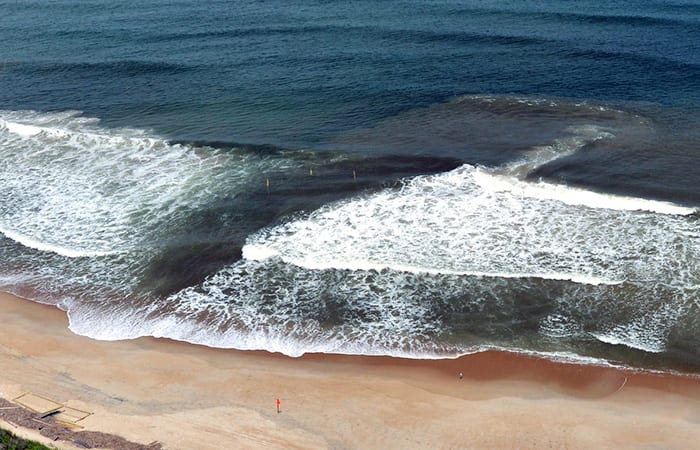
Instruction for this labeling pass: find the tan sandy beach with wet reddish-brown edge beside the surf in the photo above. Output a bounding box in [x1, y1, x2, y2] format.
[0, 294, 700, 449]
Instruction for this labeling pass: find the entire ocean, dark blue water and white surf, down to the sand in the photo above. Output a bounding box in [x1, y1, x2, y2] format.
[0, 0, 700, 374]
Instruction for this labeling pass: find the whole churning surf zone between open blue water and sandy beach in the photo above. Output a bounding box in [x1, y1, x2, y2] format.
[0, 98, 700, 372]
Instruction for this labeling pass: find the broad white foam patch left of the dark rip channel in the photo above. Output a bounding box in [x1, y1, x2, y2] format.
[0, 111, 300, 257]
